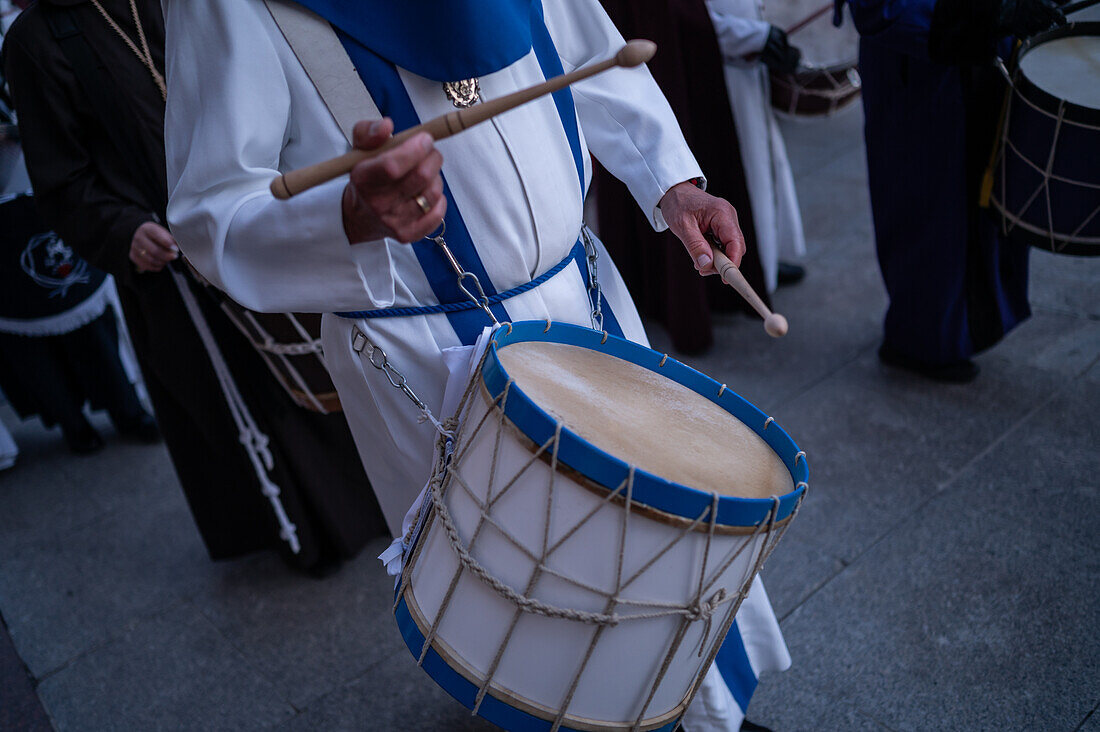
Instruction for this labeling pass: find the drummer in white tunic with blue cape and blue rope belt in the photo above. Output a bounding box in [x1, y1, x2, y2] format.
[165, 0, 790, 732]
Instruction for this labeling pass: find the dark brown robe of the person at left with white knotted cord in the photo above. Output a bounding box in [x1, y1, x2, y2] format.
[3, 0, 385, 559]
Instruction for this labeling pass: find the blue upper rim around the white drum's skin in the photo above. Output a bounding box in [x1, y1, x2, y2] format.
[482, 320, 810, 528]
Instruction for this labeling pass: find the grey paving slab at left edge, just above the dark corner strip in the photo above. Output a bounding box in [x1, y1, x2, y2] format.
[0, 482, 216, 678]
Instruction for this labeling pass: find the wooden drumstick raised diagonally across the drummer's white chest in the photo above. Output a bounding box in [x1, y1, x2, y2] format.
[271, 40, 657, 200]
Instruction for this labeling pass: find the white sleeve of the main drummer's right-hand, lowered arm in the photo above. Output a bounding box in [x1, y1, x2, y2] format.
[543, 0, 703, 231]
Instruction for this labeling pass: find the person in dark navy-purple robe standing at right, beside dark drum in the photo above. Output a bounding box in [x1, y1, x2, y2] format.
[836, 0, 1060, 382]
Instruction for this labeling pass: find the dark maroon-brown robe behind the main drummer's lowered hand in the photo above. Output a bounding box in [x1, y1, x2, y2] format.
[595, 0, 768, 353]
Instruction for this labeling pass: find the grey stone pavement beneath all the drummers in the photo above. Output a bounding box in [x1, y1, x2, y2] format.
[0, 105, 1100, 732]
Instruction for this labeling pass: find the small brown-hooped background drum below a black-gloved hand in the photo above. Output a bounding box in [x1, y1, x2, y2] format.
[763, 0, 860, 117]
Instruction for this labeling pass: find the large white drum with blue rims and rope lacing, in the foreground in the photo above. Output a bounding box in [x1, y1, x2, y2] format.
[395, 321, 809, 731]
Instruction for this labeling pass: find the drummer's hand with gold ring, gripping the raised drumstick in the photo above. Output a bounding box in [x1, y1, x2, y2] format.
[343, 118, 447, 244]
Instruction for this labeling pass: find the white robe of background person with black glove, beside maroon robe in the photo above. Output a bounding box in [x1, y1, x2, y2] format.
[706, 0, 806, 292]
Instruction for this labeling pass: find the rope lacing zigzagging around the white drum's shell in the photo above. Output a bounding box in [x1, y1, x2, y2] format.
[397, 352, 804, 732]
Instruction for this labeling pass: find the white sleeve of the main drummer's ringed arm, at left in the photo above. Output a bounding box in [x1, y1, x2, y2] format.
[165, 0, 394, 312]
